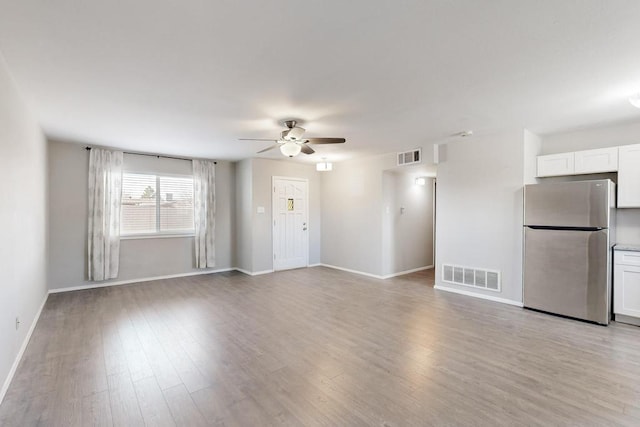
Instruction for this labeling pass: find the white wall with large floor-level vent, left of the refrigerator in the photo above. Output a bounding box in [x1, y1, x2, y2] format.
[436, 129, 525, 302]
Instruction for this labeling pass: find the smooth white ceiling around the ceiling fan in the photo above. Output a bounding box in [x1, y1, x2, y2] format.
[0, 0, 640, 161]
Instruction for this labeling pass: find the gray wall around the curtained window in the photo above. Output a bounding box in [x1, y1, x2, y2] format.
[49, 141, 235, 289]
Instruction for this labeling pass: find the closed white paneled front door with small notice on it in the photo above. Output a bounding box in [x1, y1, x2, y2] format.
[272, 177, 309, 270]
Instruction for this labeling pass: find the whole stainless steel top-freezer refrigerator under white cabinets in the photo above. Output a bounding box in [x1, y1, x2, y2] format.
[523, 179, 615, 325]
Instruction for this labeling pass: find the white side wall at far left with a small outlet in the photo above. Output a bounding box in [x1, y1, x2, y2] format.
[0, 56, 47, 401]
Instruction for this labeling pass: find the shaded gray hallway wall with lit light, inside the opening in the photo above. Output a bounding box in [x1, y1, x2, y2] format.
[382, 168, 433, 276]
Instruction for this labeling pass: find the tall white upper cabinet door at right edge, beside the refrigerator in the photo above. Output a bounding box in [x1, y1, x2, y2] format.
[618, 144, 640, 208]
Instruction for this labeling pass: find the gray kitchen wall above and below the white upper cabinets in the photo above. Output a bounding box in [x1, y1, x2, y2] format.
[541, 122, 640, 244]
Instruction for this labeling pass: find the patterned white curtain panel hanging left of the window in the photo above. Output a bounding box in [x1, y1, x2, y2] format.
[88, 148, 123, 281]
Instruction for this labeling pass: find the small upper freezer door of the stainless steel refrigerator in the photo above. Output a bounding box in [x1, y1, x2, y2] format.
[524, 179, 615, 228]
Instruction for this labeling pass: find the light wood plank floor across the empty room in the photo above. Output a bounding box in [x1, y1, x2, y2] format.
[0, 267, 640, 426]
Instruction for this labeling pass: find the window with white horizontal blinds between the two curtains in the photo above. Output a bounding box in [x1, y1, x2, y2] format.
[120, 172, 194, 236]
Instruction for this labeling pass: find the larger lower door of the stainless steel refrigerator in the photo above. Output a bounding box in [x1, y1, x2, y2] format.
[523, 227, 611, 325]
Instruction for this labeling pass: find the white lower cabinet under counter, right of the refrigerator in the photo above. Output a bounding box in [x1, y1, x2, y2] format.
[613, 250, 640, 325]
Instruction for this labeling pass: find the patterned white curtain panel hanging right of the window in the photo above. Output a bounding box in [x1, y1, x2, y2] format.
[193, 160, 216, 268]
